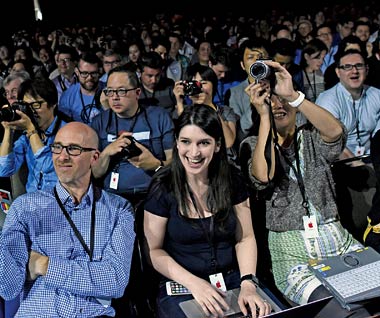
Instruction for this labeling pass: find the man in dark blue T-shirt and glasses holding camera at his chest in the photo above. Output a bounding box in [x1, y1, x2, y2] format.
[91, 66, 174, 206]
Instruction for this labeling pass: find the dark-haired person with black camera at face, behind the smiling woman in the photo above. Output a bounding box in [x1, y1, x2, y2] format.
[173, 63, 238, 164]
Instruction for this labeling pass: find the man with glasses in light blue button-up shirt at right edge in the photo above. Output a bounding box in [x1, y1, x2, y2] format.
[316, 49, 380, 159]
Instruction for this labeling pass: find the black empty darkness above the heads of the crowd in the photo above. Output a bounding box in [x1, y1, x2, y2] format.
[0, 0, 374, 39]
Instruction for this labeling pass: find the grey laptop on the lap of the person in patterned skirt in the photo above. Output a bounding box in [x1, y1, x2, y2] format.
[309, 247, 380, 310]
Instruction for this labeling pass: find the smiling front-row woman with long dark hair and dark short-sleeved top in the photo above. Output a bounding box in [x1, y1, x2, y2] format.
[144, 104, 271, 318]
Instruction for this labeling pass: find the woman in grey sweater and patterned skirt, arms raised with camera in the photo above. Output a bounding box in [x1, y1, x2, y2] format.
[240, 61, 367, 317]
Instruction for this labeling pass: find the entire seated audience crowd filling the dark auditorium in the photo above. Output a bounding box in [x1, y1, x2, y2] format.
[0, 3, 380, 318]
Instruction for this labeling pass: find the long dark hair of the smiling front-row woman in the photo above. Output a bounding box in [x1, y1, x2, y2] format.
[170, 104, 236, 222]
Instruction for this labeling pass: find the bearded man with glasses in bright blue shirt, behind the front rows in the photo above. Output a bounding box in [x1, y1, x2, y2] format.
[58, 52, 104, 124]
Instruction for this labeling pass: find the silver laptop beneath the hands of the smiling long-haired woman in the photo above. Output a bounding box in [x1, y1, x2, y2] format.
[179, 287, 284, 318]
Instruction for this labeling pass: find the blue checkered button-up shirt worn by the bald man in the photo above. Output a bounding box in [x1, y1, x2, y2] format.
[0, 183, 135, 318]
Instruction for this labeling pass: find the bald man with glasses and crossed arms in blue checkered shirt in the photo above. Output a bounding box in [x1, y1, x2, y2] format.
[0, 122, 135, 318]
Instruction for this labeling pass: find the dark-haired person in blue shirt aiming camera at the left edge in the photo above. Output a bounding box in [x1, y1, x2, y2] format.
[0, 76, 65, 192]
